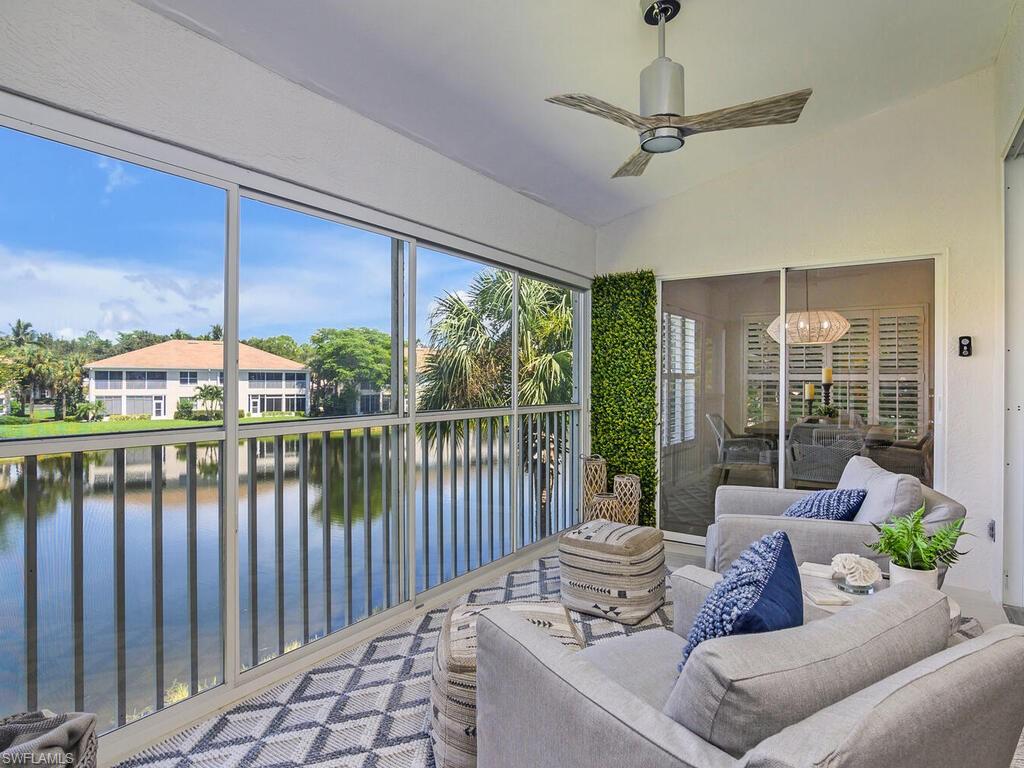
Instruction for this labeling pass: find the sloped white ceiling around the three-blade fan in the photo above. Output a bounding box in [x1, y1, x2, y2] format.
[136, 0, 1012, 224]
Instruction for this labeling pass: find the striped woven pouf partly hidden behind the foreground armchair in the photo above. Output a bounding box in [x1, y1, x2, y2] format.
[430, 600, 584, 768]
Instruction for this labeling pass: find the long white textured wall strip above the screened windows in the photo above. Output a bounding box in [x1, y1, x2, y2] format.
[0, 0, 594, 276]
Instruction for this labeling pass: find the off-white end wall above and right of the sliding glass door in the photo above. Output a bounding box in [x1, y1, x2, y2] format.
[597, 69, 1002, 594]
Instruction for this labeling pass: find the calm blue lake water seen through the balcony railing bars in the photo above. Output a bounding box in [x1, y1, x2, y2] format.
[0, 428, 570, 731]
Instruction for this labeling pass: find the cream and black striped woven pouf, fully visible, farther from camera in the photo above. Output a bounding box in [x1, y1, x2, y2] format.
[558, 520, 665, 625]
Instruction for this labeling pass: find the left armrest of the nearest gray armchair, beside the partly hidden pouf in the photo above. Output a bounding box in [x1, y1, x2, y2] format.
[476, 607, 735, 768]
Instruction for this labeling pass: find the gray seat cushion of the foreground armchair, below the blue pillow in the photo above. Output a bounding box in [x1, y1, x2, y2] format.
[580, 629, 686, 710]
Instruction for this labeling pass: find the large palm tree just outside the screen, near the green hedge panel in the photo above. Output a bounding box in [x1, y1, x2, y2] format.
[417, 270, 573, 537]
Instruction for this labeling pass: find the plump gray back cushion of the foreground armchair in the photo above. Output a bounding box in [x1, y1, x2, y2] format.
[664, 583, 949, 757]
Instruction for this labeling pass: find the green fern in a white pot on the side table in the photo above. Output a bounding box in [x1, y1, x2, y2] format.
[867, 507, 970, 589]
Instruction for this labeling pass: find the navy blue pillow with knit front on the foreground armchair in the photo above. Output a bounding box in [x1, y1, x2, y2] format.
[679, 530, 804, 671]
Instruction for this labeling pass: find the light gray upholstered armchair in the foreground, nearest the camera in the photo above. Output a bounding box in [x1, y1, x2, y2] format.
[477, 566, 1024, 768]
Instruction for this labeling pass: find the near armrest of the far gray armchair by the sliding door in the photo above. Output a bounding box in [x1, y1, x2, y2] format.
[709, 515, 889, 571]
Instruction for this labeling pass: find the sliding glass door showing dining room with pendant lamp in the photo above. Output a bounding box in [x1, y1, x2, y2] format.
[658, 259, 935, 542]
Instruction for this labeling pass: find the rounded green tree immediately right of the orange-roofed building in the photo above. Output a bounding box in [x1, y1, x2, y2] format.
[307, 328, 391, 414]
